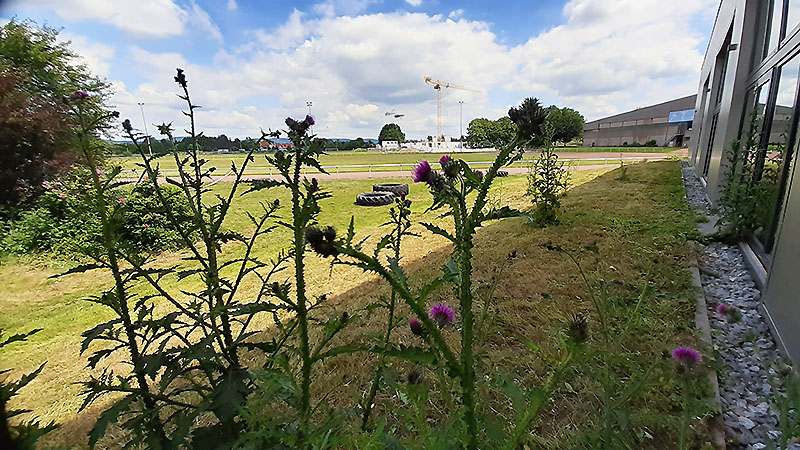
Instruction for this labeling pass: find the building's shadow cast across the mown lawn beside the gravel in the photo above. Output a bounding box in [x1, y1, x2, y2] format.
[42, 162, 702, 448]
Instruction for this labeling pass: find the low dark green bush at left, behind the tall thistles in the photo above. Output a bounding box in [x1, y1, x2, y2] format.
[0, 170, 191, 256]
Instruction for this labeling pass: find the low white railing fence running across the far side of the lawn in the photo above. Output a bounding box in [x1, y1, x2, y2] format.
[117, 154, 673, 177]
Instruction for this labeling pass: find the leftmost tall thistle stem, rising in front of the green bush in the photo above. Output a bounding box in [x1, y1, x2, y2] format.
[62, 91, 172, 448]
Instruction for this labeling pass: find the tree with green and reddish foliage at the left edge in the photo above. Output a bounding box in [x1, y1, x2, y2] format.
[0, 20, 110, 208]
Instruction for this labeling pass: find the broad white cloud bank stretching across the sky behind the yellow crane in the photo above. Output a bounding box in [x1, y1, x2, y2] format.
[57, 0, 714, 138]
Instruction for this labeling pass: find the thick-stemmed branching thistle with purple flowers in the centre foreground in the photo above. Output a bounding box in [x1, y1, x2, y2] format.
[310, 99, 580, 449]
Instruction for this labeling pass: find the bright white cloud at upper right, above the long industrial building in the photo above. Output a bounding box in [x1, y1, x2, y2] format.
[507, 0, 717, 117]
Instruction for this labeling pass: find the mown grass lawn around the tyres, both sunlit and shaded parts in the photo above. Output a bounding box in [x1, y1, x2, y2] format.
[0, 161, 710, 449]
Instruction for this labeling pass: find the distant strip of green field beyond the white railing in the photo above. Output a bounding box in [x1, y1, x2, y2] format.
[111, 147, 675, 175]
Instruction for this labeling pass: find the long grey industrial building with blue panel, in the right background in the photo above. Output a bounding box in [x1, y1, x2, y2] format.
[583, 95, 697, 147]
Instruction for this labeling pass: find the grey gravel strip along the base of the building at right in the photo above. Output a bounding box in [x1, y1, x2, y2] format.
[682, 167, 800, 450]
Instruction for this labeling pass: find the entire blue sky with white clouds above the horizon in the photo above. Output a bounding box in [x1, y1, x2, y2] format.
[0, 0, 718, 138]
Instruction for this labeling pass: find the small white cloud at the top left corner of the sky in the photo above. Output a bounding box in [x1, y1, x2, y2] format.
[20, 0, 222, 40]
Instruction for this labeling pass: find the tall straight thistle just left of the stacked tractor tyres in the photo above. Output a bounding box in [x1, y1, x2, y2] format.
[238, 116, 362, 448]
